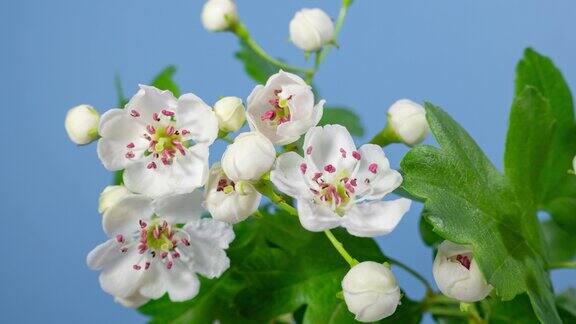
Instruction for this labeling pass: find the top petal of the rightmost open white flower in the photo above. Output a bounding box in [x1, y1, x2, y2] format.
[303, 125, 357, 174]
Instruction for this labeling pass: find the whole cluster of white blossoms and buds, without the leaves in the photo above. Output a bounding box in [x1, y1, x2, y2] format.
[65, 0, 491, 322]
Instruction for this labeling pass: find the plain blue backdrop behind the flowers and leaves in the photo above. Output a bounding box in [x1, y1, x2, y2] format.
[0, 0, 576, 323]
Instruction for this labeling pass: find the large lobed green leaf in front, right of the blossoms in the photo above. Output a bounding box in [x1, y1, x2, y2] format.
[401, 103, 560, 323]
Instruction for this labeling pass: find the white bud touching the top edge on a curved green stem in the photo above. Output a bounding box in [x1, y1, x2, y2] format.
[202, 0, 238, 32]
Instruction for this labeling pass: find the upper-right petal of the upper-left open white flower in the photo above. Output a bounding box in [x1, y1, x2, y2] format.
[176, 93, 218, 145]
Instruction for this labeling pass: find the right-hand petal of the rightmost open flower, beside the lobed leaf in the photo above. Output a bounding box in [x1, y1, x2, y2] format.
[355, 144, 402, 199]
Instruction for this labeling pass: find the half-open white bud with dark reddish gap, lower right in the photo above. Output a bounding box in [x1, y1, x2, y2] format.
[432, 241, 492, 303]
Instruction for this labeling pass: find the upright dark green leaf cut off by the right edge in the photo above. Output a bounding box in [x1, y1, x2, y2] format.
[506, 49, 576, 233]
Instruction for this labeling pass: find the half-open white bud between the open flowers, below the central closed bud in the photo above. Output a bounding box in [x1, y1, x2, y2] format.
[206, 163, 262, 224]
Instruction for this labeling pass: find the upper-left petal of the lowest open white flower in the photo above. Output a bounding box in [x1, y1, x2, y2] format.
[102, 195, 154, 237]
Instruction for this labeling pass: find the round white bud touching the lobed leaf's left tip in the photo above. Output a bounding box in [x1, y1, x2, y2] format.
[388, 99, 430, 146]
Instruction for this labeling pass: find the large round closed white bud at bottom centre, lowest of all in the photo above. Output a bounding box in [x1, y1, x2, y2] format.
[342, 261, 401, 322]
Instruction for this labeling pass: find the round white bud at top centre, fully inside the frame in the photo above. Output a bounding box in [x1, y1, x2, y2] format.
[290, 8, 334, 52]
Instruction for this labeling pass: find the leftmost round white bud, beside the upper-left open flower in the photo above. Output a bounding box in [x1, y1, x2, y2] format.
[64, 105, 100, 145]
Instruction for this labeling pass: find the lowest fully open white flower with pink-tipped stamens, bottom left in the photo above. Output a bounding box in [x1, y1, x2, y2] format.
[87, 191, 234, 307]
